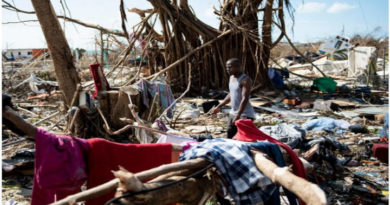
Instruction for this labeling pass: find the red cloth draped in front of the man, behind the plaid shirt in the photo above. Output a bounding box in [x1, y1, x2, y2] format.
[233, 119, 307, 204]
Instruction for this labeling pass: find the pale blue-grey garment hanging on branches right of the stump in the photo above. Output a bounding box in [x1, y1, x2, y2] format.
[135, 79, 175, 118]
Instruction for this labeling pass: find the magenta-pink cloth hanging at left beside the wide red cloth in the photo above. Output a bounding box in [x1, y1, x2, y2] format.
[31, 128, 89, 205]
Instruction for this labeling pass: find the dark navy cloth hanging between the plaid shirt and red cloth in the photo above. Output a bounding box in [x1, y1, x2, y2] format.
[251, 141, 297, 205]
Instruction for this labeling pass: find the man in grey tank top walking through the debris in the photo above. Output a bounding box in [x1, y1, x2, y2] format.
[211, 58, 255, 139]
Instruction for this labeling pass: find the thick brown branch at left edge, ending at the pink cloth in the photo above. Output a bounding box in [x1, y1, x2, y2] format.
[3, 106, 37, 138]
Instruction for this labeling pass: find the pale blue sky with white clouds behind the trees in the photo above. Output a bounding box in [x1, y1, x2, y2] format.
[1, 0, 389, 50]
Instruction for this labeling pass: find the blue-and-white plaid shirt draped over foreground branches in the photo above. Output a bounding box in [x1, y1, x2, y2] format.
[179, 138, 277, 205]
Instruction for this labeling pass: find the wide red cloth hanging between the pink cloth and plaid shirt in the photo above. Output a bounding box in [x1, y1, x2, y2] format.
[87, 138, 172, 205]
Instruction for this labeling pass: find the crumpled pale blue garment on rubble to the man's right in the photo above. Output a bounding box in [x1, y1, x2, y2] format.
[302, 117, 351, 132]
